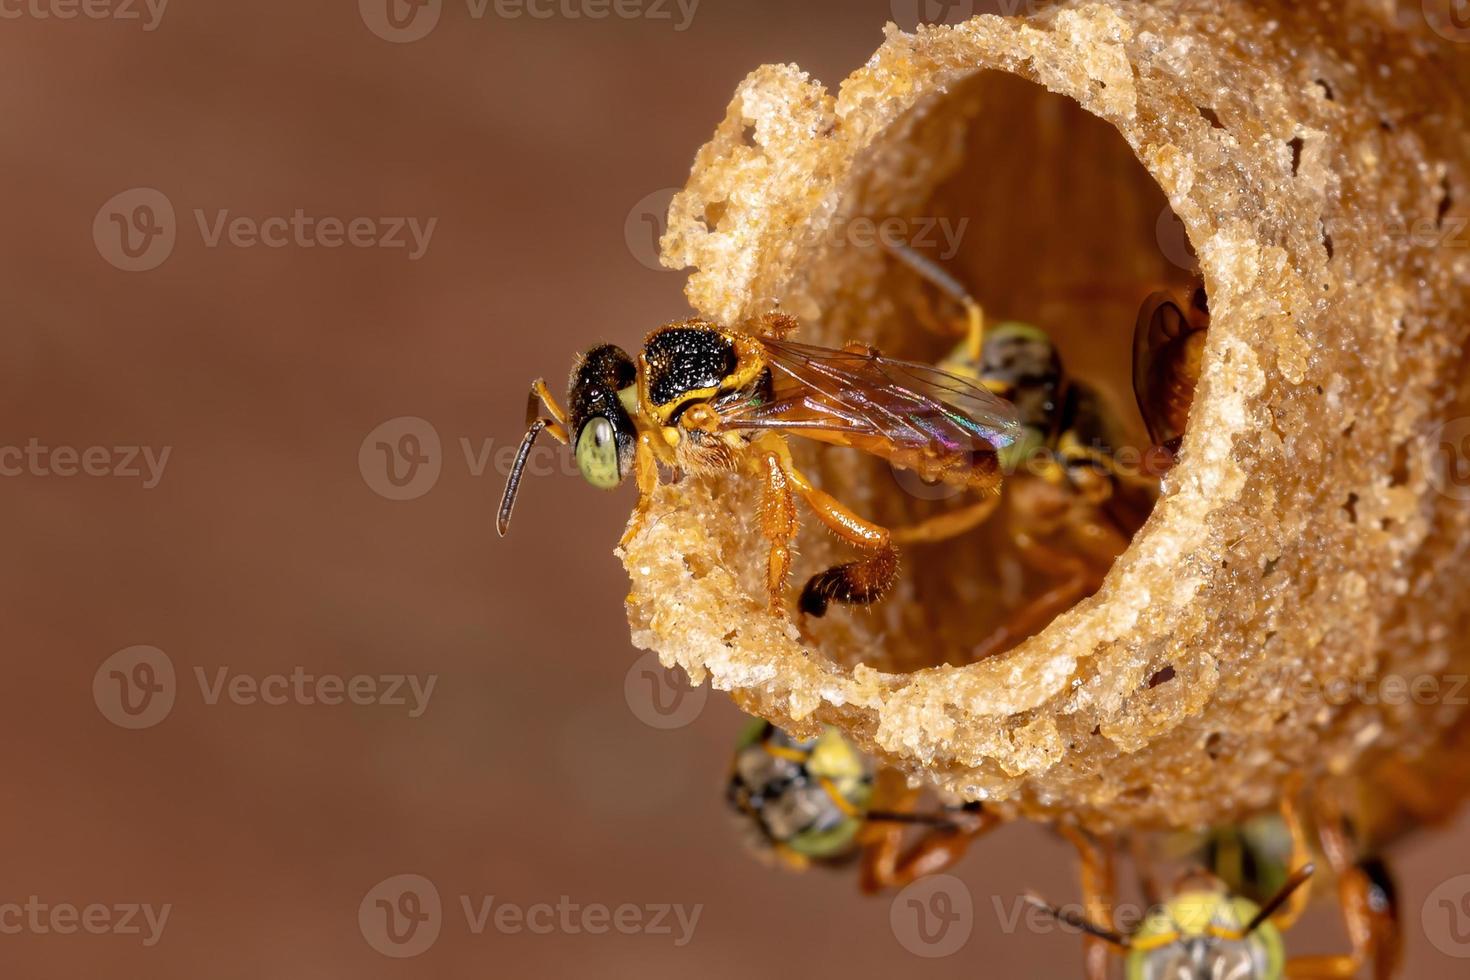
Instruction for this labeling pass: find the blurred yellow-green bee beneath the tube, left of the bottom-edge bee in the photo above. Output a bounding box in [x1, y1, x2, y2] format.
[726, 720, 1001, 893]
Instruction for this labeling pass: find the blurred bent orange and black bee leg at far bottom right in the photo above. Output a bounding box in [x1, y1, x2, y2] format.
[1286, 804, 1402, 980]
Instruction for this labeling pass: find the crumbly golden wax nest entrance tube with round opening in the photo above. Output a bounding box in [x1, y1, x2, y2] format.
[622, 0, 1470, 829]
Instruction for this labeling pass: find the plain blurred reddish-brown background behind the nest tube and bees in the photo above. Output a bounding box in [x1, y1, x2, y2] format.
[0, 0, 1470, 979]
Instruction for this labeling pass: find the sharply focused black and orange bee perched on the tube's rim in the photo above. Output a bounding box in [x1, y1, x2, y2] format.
[498, 313, 1020, 616]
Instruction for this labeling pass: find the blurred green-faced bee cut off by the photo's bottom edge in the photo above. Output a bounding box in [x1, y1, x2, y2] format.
[1028, 789, 1401, 980]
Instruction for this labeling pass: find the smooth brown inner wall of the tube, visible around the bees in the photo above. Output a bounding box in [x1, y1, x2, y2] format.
[797, 72, 1200, 671]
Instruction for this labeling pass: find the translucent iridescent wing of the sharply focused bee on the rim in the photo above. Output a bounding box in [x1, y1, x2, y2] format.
[720, 338, 1020, 454]
